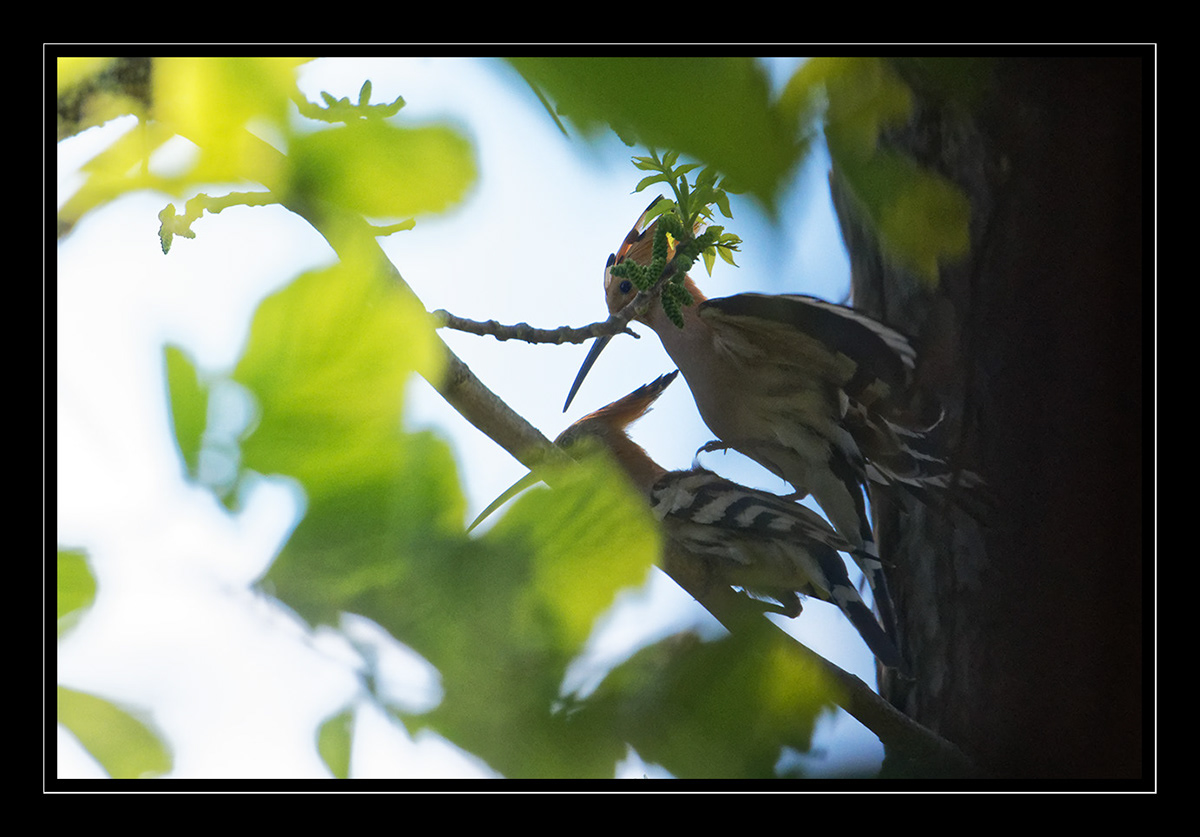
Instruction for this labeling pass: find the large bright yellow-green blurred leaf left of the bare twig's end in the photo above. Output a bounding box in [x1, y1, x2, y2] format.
[234, 235, 442, 500]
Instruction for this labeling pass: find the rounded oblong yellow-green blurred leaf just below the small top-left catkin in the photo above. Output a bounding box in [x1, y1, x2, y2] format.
[288, 120, 475, 218]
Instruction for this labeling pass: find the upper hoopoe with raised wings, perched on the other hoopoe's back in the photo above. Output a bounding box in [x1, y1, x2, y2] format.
[563, 200, 969, 622]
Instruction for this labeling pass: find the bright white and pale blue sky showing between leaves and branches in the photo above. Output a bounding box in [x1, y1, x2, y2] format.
[56, 59, 882, 778]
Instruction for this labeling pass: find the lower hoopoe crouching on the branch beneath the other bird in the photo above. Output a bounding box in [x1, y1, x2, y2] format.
[472, 371, 902, 668]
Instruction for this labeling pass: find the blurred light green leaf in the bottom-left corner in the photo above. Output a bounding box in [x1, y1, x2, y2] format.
[58, 686, 172, 778]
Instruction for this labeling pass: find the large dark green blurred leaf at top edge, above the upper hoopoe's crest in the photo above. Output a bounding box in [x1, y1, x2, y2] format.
[510, 58, 808, 209]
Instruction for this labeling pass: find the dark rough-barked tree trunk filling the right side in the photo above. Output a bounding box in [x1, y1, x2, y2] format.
[830, 58, 1148, 779]
